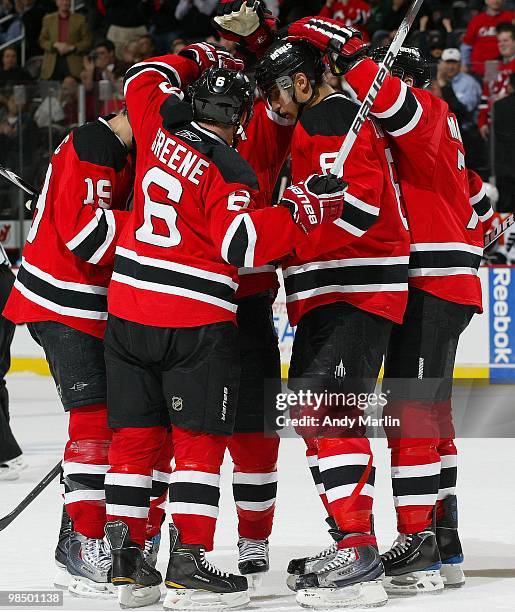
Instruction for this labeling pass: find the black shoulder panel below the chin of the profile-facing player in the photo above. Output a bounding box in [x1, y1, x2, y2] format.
[300, 93, 358, 136]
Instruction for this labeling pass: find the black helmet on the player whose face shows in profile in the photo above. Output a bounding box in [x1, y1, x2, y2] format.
[256, 40, 325, 104]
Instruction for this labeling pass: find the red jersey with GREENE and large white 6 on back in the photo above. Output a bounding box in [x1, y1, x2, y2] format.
[109, 56, 304, 327]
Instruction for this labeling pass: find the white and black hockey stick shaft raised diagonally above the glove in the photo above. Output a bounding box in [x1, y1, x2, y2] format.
[330, 0, 424, 176]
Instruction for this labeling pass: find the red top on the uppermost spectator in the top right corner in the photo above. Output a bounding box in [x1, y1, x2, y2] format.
[463, 11, 515, 75]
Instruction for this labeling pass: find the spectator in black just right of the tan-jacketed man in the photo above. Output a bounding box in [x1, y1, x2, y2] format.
[102, 0, 149, 59]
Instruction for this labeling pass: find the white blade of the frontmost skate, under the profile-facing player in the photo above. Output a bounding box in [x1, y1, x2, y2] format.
[296, 580, 388, 609]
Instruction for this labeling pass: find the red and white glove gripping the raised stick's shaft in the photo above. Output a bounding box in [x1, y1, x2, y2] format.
[279, 174, 347, 234]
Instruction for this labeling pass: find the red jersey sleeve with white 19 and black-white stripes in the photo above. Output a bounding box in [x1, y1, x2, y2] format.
[52, 143, 130, 265]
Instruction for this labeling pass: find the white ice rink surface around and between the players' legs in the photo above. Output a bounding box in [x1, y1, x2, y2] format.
[0, 375, 515, 612]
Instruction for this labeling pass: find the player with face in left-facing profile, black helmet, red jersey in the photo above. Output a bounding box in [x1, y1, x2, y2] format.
[252, 40, 409, 607]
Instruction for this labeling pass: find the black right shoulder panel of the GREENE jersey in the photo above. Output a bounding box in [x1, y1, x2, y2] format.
[172, 124, 259, 190]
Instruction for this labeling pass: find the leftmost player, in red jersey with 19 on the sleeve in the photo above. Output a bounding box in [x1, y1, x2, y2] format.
[4, 114, 143, 597]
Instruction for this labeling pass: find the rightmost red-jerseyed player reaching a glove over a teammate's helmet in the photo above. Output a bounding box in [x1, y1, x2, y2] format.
[289, 18, 496, 594]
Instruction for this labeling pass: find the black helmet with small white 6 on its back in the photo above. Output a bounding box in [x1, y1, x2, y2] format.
[188, 68, 254, 127]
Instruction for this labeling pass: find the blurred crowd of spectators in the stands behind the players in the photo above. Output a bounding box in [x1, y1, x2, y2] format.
[0, 0, 515, 230]
